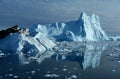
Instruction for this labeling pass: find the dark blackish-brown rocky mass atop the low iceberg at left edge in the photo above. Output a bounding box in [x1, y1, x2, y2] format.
[0, 25, 21, 39]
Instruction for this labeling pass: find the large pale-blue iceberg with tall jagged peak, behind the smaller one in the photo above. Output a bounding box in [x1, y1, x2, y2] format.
[31, 13, 108, 41]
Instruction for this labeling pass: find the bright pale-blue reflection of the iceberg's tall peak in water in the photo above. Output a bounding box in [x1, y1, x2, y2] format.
[81, 43, 107, 69]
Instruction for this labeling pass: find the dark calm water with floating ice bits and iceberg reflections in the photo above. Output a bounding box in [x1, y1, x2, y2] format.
[0, 42, 120, 79]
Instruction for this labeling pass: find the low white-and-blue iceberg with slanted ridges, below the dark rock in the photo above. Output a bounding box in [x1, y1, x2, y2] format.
[0, 33, 55, 53]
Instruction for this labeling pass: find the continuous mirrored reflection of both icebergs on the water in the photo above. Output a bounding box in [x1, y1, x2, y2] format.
[18, 42, 107, 69]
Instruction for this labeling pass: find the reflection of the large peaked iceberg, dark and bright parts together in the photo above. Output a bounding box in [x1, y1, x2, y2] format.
[53, 43, 107, 69]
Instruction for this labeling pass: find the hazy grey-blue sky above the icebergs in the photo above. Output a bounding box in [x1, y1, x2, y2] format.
[0, 0, 120, 34]
